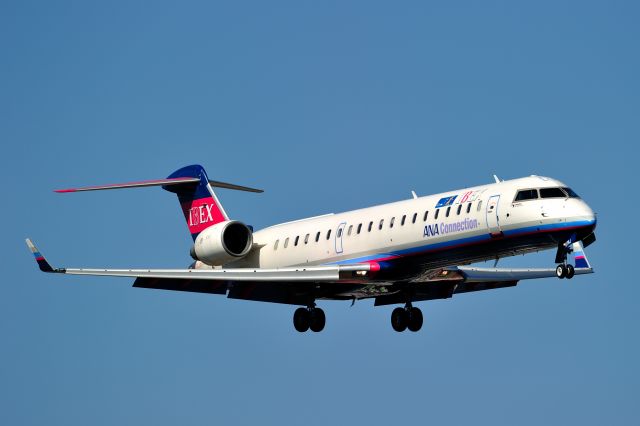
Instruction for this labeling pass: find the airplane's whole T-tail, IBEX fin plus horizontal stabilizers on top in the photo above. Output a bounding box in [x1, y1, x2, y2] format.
[55, 164, 263, 241]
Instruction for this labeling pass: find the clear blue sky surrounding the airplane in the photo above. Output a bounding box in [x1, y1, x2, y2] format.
[0, 1, 640, 425]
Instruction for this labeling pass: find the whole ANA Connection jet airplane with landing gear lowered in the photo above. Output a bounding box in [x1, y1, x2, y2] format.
[26, 165, 597, 332]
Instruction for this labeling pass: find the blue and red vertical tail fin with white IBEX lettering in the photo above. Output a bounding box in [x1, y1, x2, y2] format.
[162, 164, 229, 241]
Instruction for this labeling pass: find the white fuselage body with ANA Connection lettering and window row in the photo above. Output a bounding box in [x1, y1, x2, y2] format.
[225, 176, 596, 268]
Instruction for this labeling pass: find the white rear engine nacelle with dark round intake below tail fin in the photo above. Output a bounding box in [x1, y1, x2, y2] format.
[191, 220, 253, 266]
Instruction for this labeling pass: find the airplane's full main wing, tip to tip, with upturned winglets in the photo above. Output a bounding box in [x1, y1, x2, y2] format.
[26, 239, 593, 306]
